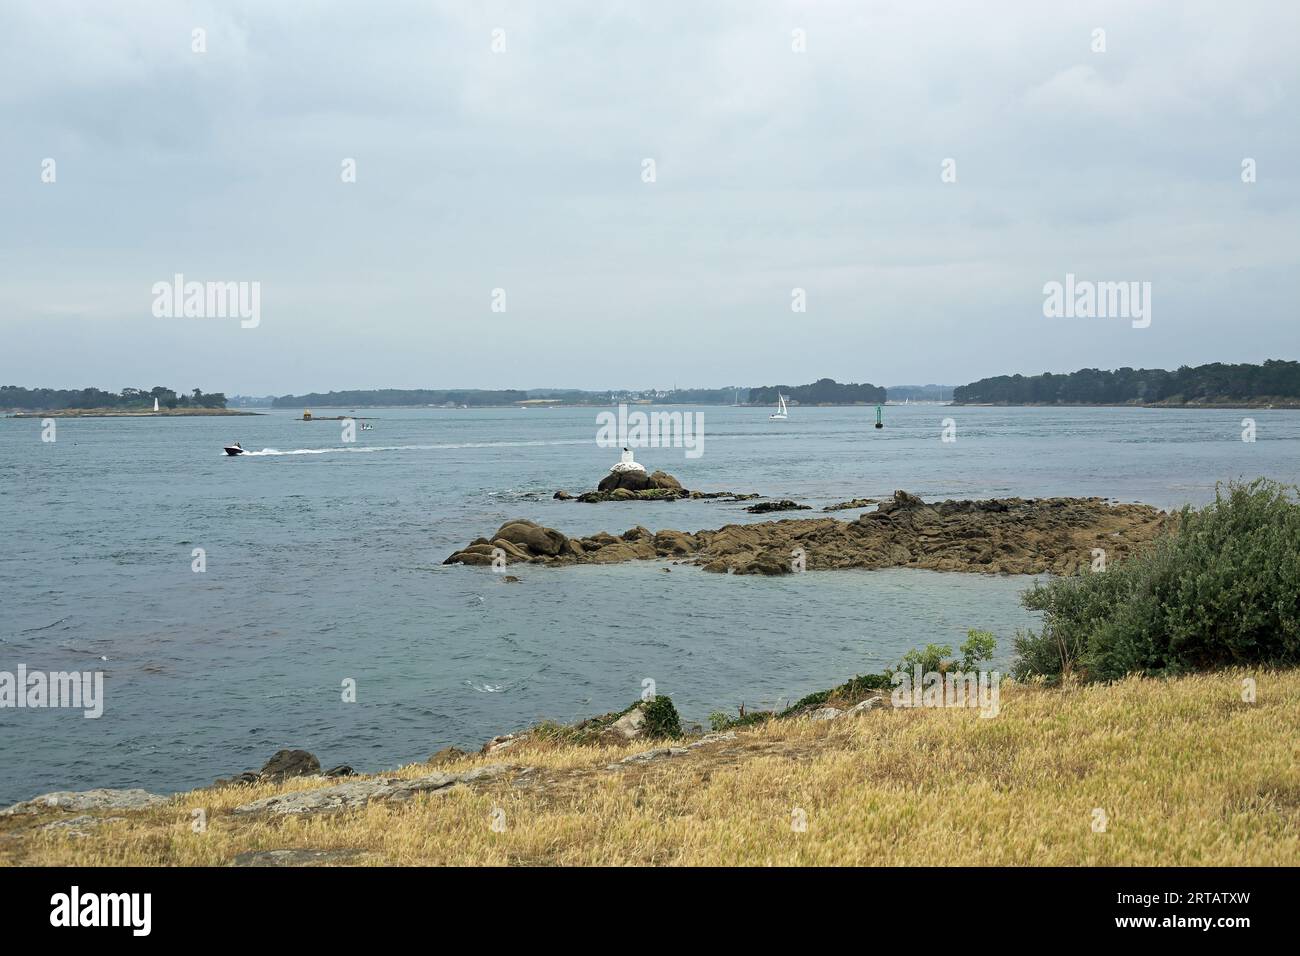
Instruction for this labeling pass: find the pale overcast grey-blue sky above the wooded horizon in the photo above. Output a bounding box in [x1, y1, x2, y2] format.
[0, 0, 1300, 395]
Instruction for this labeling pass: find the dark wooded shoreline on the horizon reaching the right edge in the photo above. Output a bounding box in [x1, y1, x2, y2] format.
[953, 359, 1300, 405]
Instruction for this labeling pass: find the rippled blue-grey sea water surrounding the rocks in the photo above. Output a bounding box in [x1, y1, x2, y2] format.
[0, 406, 1300, 804]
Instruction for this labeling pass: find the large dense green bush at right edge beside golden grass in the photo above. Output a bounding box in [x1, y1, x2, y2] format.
[1013, 479, 1300, 680]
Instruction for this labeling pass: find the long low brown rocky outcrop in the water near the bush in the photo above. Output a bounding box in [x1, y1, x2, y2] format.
[443, 492, 1174, 575]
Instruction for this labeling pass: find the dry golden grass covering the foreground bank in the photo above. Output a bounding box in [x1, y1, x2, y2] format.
[0, 671, 1300, 866]
